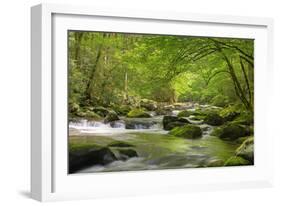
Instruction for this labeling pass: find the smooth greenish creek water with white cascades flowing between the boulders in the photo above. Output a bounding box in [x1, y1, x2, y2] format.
[69, 106, 239, 173]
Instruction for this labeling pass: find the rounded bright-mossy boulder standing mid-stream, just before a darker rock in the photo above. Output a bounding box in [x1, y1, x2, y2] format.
[169, 124, 202, 139]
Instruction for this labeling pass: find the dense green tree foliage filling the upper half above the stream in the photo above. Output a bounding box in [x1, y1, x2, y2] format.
[68, 31, 254, 115]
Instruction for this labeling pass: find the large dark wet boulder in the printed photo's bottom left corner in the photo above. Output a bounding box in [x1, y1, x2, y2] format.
[69, 143, 117, 173]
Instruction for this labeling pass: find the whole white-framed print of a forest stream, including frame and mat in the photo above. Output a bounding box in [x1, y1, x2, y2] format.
[31, 4, 273, 201]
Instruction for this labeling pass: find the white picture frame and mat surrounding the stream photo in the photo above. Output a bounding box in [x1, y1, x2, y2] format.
[31, 4, 274, 201]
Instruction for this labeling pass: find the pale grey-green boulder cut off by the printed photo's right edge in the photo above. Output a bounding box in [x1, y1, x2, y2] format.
[236, 137, 254, 163]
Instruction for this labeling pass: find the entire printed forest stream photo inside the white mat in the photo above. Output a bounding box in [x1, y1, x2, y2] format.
[68, 31, 254, 173]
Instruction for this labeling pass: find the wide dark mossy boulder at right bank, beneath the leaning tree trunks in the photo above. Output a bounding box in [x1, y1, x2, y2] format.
[212, 123, 251, 140]
